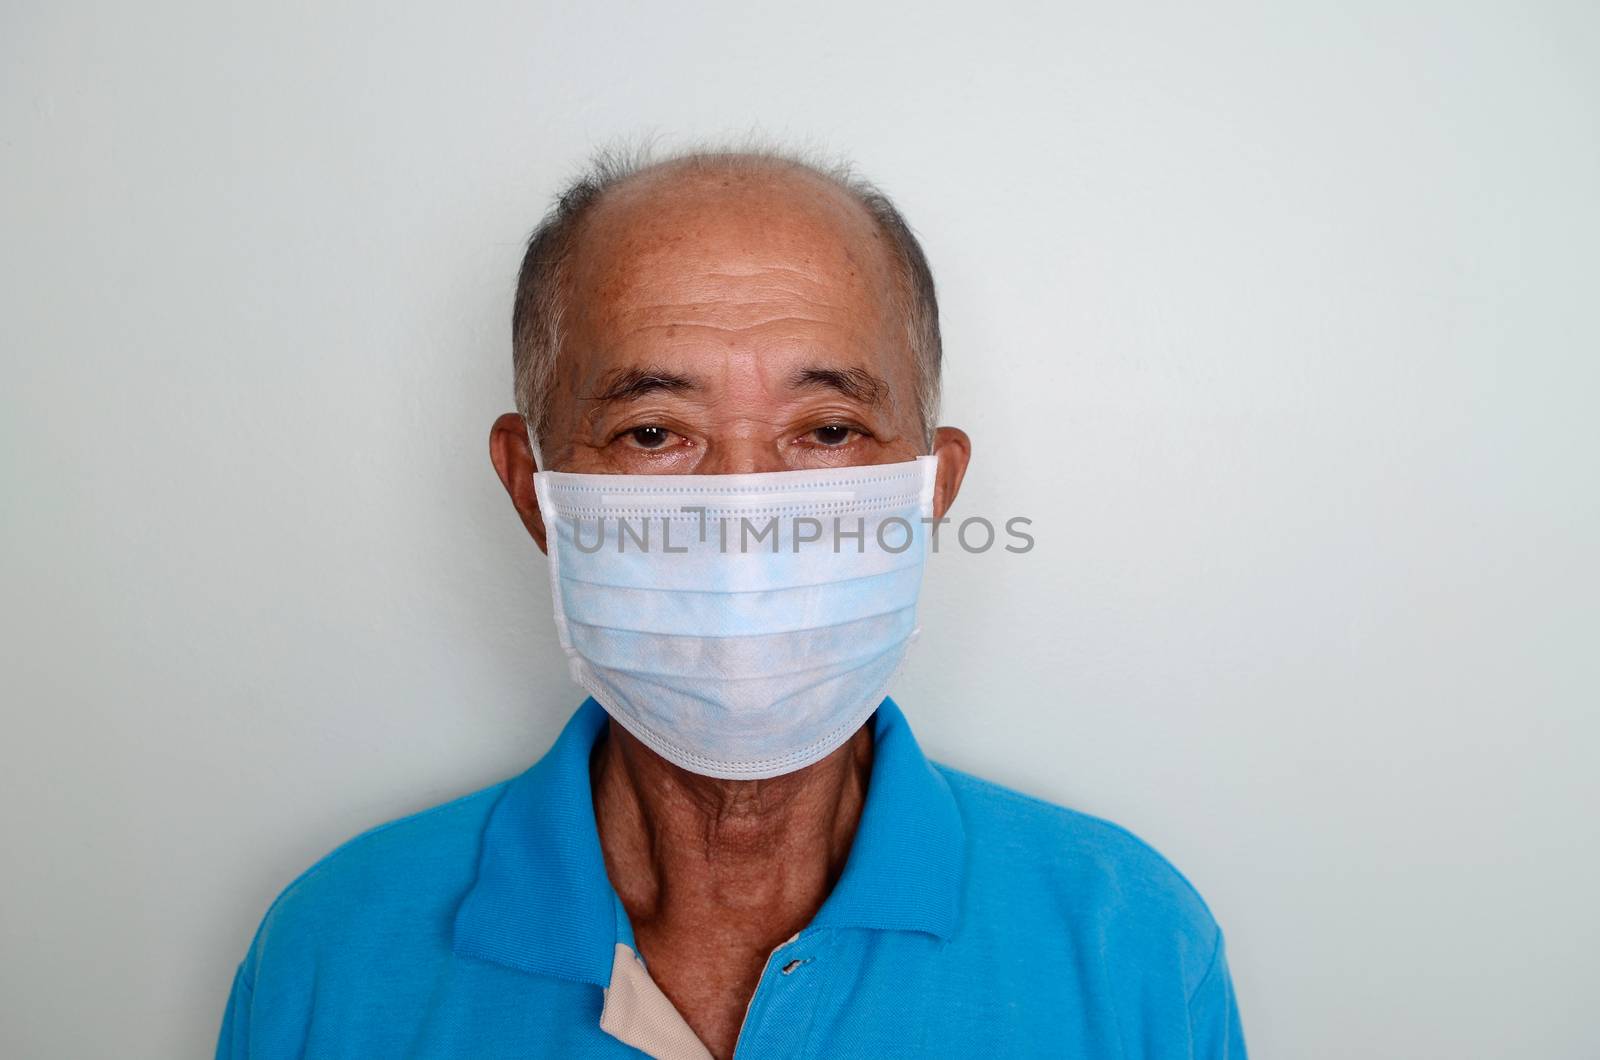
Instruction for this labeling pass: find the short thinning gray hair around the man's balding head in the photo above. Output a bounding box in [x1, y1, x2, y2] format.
[512, 140, 941, 445]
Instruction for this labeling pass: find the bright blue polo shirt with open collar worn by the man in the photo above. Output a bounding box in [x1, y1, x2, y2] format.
[218, 700, 1245, 1060]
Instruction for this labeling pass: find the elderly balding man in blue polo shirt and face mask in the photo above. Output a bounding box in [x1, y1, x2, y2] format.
[218, 145, 1243, 1060]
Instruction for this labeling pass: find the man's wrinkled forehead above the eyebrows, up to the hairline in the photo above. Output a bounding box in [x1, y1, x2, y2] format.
[568, 168, 899, 349]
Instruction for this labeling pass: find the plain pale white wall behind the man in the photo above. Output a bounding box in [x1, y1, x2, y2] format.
[0, 0, 1600, 1058]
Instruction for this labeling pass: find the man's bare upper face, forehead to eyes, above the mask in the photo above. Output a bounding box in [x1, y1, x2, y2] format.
[541, 164, 926, 474]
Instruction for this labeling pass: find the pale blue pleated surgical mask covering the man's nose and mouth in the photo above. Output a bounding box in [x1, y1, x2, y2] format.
[534, 456, 938, 780]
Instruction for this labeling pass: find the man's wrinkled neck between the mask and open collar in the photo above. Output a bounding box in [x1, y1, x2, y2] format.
[590, 721, 872, 950]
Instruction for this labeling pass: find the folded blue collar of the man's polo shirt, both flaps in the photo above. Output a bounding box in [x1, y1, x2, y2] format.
[454, 698, 965, 986]
